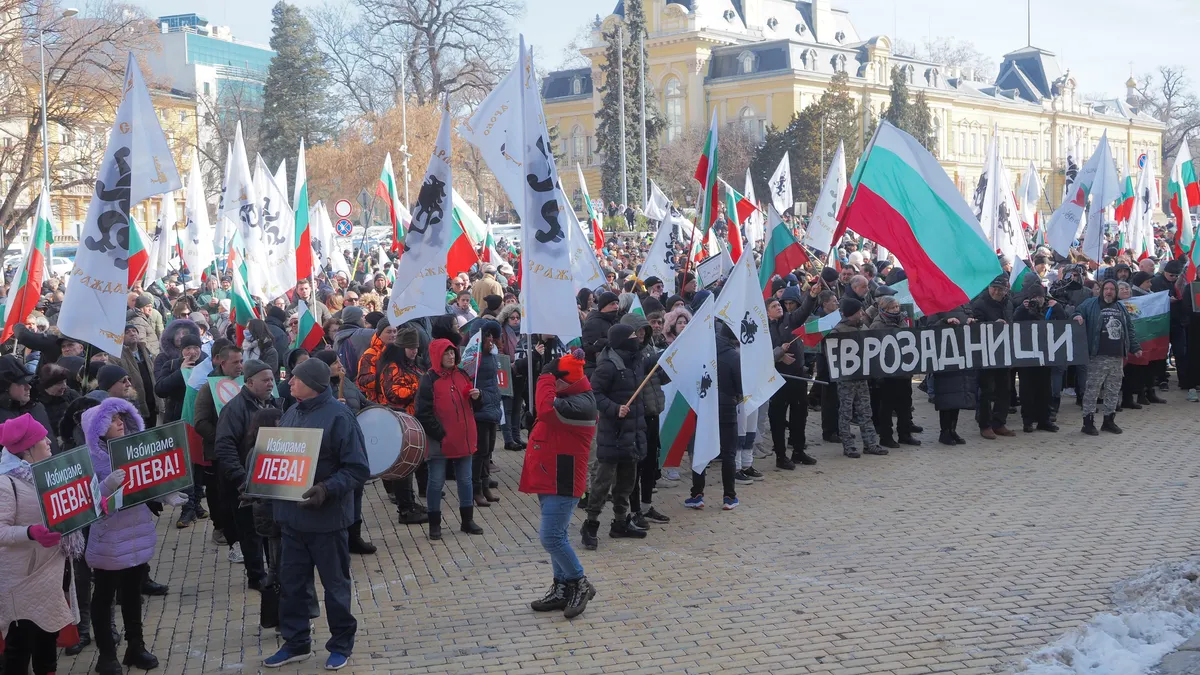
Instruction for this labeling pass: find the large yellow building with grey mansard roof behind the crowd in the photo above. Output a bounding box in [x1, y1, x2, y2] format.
[542, 0, 1164, 210]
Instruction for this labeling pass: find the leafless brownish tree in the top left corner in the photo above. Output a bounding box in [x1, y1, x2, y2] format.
[0, 0, 157, 241]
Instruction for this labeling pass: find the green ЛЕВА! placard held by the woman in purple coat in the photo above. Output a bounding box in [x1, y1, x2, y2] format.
[108, 420, 192, 509]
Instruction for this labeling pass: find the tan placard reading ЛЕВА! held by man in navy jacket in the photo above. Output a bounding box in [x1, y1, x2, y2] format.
[246, 426, 324, 502]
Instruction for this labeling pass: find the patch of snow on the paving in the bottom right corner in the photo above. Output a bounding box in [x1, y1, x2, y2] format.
[1016, 558, 1200, 675]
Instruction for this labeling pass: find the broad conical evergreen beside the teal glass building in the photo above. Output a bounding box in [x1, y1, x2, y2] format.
[260, 0, 336, 186]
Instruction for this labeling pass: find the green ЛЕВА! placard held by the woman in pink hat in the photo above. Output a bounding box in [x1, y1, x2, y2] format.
[31, 446, 100, 534]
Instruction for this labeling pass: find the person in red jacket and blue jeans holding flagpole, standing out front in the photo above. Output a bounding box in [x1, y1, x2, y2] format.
[520, 347, 596, 619]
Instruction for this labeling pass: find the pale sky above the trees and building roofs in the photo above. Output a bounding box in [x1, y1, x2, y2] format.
[136, 0, 1200, 95]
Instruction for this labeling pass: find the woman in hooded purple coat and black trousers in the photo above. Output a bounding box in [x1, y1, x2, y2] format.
[83, 398, 158, 675]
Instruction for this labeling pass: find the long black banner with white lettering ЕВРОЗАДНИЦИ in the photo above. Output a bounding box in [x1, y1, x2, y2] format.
[824, 321, 1087, 380]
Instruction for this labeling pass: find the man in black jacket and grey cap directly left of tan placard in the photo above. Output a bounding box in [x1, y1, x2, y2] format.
[215, 360, 278, 590]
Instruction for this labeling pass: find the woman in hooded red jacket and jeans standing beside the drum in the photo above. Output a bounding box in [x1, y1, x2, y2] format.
[416, 339, 484, 539]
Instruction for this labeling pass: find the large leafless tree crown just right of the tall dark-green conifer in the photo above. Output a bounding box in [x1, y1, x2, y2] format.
[313, 0, 524, 113]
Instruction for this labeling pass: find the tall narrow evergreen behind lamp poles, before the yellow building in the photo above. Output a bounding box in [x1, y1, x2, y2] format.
[596, 0, 667, 205]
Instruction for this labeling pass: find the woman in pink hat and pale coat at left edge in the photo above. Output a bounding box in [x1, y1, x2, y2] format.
[0, 413, 84, 675]
